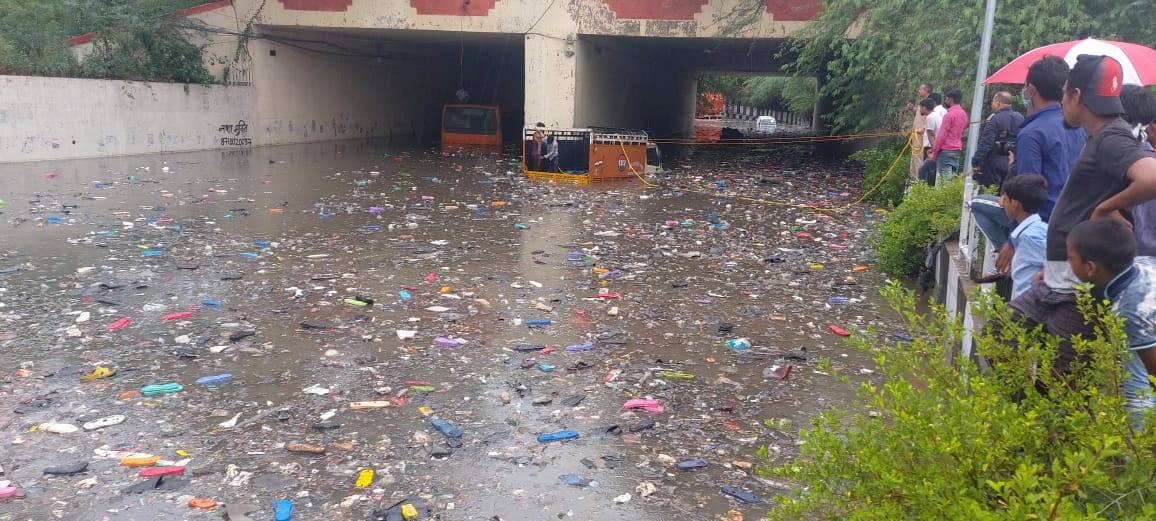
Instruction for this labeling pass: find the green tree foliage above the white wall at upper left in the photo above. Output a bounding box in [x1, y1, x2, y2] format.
[0, 0, 212, 83]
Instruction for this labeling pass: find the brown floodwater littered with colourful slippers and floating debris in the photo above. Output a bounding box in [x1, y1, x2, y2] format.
[0, 142, 892, 521]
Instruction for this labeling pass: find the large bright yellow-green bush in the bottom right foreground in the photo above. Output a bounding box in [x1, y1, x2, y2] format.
[759, 283, 1156, 521]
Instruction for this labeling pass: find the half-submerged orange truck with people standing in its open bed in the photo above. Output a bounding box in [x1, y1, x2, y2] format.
[521, 127, 650, 183]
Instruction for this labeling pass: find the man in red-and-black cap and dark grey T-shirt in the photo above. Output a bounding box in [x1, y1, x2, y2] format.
[1012, 54, 1156, 371]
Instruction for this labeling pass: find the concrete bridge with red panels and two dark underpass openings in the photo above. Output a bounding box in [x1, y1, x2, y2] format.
[67, 0, 821, 144]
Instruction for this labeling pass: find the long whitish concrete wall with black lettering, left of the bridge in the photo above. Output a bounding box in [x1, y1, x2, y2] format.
[0, 76, 257, 162]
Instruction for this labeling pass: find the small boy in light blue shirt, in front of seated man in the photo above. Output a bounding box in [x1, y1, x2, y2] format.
[1000, 173, 1047, 298]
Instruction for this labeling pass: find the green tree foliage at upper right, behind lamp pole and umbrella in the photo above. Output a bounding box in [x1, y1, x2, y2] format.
[786, 0, 1156, 132]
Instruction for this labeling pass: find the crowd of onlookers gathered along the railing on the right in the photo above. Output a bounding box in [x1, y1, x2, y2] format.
[911, 54, 1156, 427]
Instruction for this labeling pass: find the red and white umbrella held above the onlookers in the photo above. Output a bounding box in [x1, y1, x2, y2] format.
[984, 38, 1156, 85]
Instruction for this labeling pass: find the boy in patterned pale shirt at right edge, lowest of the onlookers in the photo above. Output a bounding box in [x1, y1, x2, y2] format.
[1067, 218, 1156, 426]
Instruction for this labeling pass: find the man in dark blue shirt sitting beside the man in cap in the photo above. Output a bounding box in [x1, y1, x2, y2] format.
[971, 55, 1088, 277]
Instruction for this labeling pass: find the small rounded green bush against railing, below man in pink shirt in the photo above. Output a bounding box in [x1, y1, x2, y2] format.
[875, 177, 963, 277]
